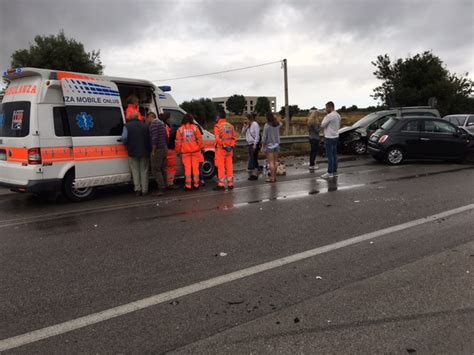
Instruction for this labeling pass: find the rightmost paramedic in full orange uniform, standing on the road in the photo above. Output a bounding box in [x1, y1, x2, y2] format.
[214, 111, 237, 190]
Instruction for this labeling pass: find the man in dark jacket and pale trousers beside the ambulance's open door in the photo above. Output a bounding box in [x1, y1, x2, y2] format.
[122, 112, 151, 196]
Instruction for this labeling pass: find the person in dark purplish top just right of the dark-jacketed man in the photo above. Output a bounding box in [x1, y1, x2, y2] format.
[146, 112, 168, 196]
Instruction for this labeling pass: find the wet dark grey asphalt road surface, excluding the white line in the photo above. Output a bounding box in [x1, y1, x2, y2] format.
[0, 159, 474, 354]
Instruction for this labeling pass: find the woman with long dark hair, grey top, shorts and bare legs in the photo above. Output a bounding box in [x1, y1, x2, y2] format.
[262, 112, 282, 182]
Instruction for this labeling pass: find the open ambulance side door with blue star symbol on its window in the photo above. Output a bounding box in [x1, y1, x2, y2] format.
[61, 79, 130, 188]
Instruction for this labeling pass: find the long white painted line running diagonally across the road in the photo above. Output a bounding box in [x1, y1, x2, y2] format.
[0, 204, 474, 351]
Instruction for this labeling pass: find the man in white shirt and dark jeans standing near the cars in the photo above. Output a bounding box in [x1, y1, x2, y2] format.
[321, 101, 341, 179]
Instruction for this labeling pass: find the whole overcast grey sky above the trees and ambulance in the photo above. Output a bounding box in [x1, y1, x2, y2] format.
[0, 0, 474, 108]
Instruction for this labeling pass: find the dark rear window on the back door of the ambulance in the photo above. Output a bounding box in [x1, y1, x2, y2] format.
[0, 101, 31, 137]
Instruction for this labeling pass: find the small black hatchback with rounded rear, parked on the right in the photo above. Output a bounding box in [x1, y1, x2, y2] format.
[368, 117, 474, 165]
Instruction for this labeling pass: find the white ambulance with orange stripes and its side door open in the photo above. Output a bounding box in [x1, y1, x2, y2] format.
[0, 68, 216, 201]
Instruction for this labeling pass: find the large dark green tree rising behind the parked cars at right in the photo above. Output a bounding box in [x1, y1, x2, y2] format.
[372, 51, 473, 115]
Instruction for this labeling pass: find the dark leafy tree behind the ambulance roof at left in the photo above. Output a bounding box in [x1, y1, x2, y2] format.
[11, 31, 104, 74]
